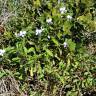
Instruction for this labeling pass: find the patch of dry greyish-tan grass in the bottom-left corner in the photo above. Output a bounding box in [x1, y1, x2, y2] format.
[0, 76, 21, 96]
